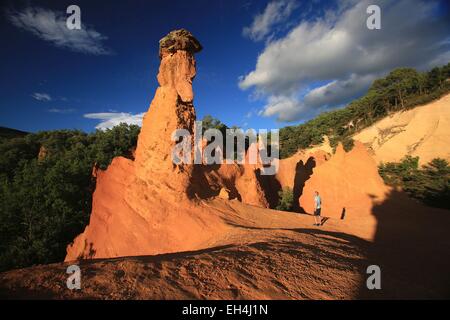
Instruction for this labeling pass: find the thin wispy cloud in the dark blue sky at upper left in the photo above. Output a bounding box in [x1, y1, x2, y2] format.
[7, 7, 111, 55]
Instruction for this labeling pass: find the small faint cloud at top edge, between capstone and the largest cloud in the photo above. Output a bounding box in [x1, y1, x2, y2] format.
[242, 0, 297, 41]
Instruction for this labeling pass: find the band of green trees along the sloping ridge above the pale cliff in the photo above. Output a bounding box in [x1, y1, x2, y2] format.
[280, 63, 450, 158]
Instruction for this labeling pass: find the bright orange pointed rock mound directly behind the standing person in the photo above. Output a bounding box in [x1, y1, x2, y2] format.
[299, 141, 390, 220]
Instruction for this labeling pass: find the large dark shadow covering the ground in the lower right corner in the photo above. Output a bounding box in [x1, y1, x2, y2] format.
[357, 190, 450, 299]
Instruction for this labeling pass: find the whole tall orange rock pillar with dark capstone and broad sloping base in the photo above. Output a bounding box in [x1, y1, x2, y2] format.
[66, 30, 228, 261]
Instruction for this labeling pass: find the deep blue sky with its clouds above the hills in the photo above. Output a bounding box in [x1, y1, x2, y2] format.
[0, 0, 450, 132]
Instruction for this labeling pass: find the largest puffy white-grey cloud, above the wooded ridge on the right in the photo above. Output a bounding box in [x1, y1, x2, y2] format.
[239, 0, 450, 121]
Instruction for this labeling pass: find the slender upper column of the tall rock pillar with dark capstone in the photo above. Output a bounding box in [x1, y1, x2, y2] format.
[135, 30, 201, 196]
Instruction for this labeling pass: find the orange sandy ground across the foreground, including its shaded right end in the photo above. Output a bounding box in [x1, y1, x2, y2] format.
[0, 196, 450, 299]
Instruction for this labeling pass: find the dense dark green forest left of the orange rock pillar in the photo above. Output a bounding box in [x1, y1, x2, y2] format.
[0, 124, 140, 270]
